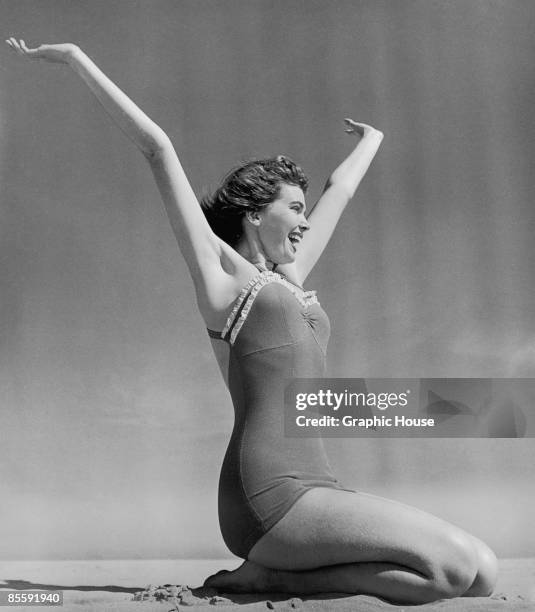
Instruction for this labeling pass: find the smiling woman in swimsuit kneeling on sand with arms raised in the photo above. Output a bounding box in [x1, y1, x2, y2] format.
[7, 38, 496, 604]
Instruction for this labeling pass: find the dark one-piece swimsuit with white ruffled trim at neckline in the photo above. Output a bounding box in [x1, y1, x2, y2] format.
[208, 271, 350, 559]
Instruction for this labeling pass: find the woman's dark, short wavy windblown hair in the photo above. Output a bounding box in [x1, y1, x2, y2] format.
[201, 155, 308, 246]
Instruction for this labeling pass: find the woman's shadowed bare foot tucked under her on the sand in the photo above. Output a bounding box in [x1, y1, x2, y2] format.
[203, 561, 278, 593]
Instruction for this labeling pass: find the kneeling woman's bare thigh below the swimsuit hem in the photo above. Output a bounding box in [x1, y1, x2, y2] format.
[248, 488, 475, 575]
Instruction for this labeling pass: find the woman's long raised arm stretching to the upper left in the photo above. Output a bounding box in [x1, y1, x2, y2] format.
[6, 38, 234, 298]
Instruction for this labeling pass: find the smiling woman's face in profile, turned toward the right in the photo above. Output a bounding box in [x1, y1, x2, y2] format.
[258, 183, 309, 264]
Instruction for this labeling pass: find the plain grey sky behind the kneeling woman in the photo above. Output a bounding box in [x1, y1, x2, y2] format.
[0, 0, 535, 559]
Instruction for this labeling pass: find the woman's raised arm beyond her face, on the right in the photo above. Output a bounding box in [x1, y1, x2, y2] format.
[295, 119, 383, 281]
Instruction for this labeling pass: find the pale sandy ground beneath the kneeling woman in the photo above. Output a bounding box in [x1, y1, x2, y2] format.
[0, 558, 535, 612]
